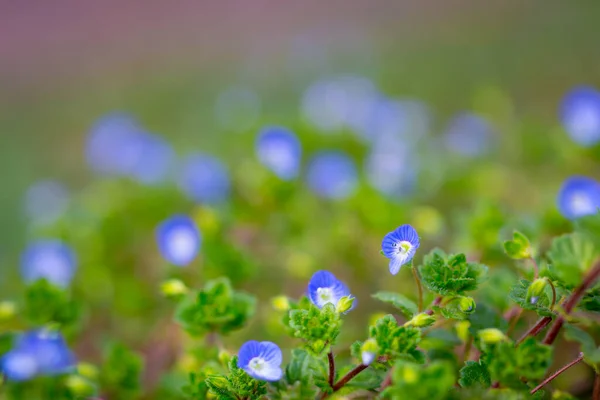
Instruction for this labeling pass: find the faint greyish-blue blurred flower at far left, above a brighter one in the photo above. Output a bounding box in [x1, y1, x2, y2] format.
[25, 180, 69, 225]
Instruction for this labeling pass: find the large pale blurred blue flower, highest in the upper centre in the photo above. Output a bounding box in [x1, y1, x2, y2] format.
[302, 75, 378, 132]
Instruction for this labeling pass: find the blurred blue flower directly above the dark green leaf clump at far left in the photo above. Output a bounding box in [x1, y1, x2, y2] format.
[21, 240, 77, 288]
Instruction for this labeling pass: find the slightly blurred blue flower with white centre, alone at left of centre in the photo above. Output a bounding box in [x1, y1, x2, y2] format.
[156, 215, 201, 267]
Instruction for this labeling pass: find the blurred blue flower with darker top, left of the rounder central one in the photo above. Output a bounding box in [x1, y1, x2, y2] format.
[256, 127, 302, 180]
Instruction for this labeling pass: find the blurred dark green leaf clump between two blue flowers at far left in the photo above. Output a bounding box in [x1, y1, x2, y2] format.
[23, 279, 81, 327]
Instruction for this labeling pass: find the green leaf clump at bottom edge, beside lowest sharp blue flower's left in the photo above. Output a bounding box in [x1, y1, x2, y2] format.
[206, 356, 267, 400]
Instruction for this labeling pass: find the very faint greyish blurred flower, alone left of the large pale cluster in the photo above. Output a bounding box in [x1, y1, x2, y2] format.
[215, 86, 261, 132]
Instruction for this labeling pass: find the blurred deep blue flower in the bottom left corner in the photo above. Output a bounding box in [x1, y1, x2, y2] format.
[0, 330, 75, 381]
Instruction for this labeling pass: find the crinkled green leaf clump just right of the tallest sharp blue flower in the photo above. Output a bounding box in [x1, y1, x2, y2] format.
[419, 249, 487, 296]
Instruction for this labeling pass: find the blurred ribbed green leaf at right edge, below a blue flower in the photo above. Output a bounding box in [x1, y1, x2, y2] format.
[548, 232, 600, 287]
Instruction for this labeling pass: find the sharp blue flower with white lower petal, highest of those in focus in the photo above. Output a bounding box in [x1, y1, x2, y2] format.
[381, 225, 420, 275]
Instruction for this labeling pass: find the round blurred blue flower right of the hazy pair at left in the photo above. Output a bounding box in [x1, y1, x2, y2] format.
[179, 153, 230, 204]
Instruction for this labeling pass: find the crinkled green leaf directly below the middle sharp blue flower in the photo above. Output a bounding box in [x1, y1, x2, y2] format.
[288, 304, 342, 356]
